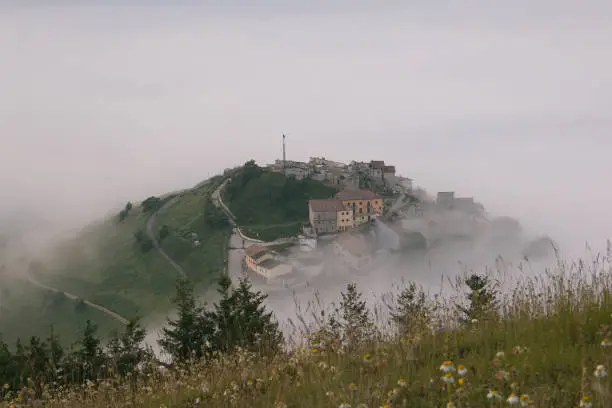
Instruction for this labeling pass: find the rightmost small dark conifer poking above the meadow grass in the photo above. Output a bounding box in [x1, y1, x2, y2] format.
[457, 274, 498, 323]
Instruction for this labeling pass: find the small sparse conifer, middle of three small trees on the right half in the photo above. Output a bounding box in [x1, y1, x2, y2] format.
[391, 282, 431, 335]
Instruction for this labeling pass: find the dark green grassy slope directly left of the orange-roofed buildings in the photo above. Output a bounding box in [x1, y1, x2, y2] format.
[223, 161, 336, 240]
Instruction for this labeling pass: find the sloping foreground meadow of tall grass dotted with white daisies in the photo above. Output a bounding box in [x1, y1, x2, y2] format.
[10, 250, 612, 408]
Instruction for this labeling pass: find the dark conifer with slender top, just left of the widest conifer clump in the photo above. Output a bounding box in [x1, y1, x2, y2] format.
[158, 279, 213, 363]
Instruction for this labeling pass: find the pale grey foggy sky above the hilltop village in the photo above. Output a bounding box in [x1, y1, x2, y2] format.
[0, 0, 612, 256]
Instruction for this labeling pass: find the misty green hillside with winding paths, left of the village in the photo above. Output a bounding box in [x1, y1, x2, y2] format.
[0, 177, 231, 342]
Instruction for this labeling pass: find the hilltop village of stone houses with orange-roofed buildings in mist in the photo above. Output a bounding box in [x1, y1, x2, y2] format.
[237, 157, 485, 280]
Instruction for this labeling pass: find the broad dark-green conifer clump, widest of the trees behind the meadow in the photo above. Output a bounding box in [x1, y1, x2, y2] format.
[210, 275, 283, 353]
